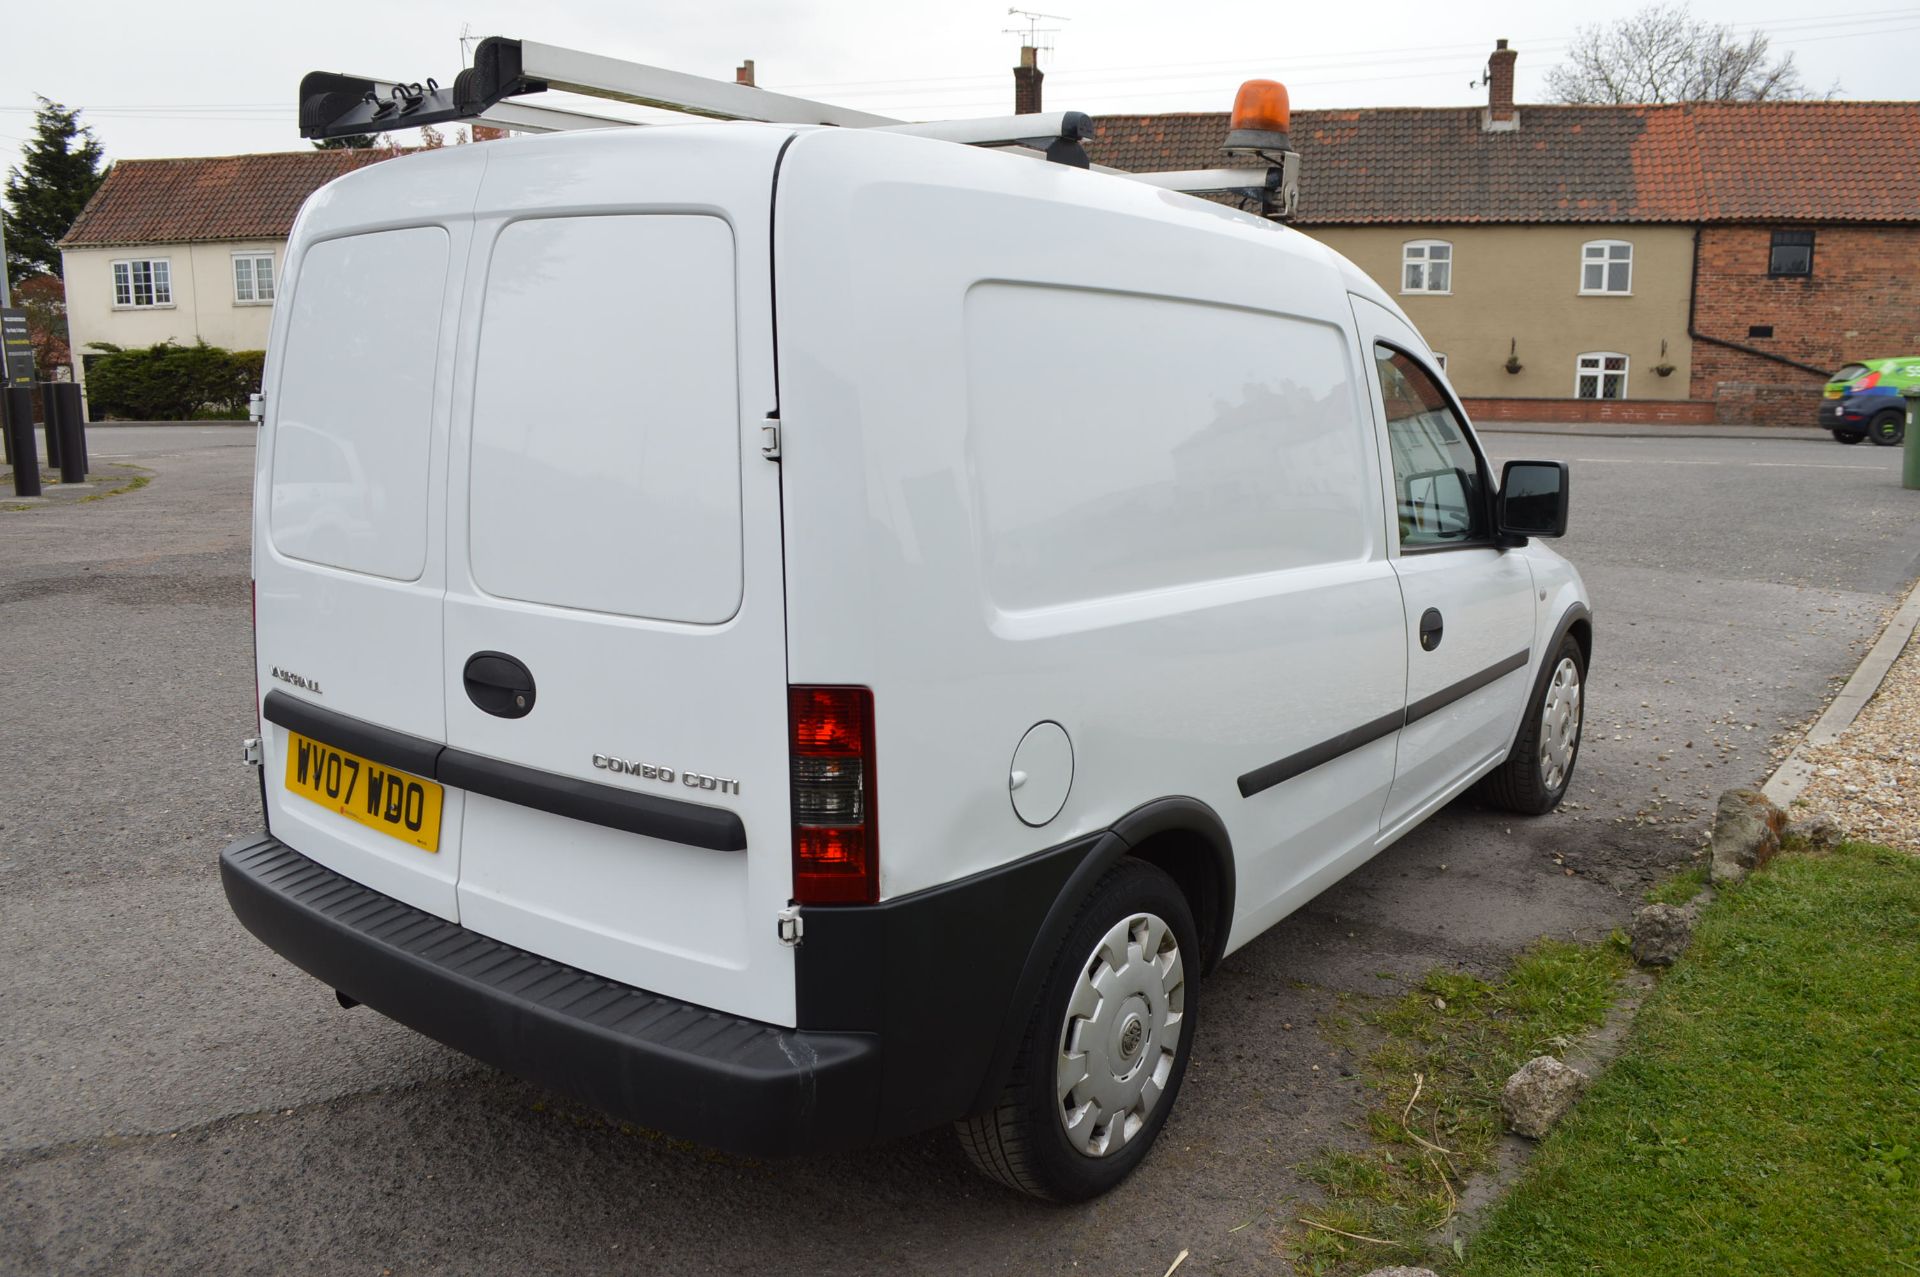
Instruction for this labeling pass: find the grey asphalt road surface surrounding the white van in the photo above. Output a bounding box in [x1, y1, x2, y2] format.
[11, 426, 1920, 1275]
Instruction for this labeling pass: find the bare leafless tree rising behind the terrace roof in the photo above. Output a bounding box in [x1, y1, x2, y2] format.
[1548, 4, 1812, 102]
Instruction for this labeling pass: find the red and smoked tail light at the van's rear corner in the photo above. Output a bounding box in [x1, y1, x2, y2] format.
[787, 687, 879, 904]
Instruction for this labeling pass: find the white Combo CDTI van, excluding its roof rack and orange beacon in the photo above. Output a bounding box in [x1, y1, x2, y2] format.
[221, 102, 1592, 1200]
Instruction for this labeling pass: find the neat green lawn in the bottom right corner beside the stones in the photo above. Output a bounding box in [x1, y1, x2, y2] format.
[1452, 845, 1920, 1277]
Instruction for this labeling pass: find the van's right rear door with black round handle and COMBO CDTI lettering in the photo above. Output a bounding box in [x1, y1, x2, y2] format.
[440, 125, 793, 1024]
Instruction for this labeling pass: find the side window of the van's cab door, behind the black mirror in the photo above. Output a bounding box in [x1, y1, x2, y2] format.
[1373, 346, 1488, 549]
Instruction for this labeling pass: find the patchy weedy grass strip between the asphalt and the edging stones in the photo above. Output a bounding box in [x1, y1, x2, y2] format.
[1286, 937, 1630, 1273]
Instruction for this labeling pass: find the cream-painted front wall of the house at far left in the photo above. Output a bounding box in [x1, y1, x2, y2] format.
[60, 240, 286, 401]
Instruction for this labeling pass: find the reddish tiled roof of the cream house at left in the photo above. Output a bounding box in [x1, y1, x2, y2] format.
[60, 150, 394, 248]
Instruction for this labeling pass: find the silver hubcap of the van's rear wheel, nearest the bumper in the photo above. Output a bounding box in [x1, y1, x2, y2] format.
[1054, 914, 1187, 1158]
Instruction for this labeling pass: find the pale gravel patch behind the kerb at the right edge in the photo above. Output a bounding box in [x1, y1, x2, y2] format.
[1793, 602, 1920, 855]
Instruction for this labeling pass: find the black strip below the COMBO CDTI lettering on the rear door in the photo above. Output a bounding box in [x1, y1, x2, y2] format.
[438, 749, 747, 851]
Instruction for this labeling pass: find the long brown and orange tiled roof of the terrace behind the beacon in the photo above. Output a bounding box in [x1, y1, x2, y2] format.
[1087, 102, 1920, 225]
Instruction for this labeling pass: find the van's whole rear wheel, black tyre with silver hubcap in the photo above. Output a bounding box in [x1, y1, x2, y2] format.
[954, 856, 1200, 1202]
